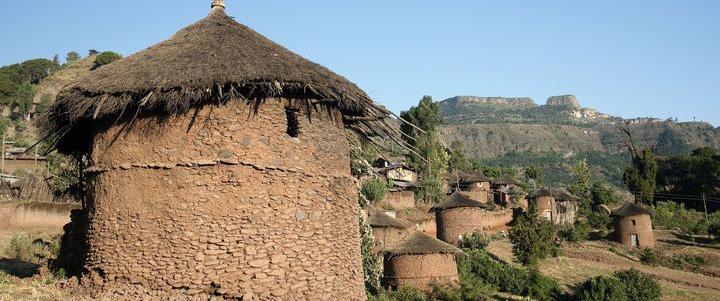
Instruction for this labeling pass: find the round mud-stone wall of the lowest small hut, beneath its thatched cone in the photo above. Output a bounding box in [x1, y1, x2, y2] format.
[383, 254, 458, 291]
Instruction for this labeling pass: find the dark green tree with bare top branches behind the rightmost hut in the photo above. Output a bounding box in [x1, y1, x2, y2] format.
[622, 124, 657, 204]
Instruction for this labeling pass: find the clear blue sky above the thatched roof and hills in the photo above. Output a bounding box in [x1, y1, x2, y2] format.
[0, 0, 720, 126]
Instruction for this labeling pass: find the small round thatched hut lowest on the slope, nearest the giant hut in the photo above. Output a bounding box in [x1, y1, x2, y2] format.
[382, 231, 461, 291]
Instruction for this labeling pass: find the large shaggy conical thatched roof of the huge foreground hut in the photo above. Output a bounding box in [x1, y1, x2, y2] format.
[41, 8, 391, 152]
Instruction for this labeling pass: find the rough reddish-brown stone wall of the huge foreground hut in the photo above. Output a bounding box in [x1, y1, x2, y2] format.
[73, 99, 365, 300]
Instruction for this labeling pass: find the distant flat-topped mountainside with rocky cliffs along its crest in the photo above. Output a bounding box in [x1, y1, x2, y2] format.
[440, 95, 720, 184]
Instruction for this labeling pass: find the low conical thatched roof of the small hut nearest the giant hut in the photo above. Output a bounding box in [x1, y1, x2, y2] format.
[383, 231, 462, 255]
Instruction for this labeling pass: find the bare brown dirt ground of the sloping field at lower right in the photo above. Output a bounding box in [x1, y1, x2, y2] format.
[488, 233, 720, 301]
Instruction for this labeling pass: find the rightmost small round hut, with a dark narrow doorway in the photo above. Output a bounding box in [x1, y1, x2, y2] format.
[613, 203, 655, 249]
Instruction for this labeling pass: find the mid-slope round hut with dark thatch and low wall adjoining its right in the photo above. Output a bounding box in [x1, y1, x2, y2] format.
[430, 192, 513, 245]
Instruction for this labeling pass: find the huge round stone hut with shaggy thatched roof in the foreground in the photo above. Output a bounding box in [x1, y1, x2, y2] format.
[43, 0, 397, 300]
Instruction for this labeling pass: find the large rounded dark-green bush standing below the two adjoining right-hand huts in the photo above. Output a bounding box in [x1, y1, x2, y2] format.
[510, 213, 557, 265]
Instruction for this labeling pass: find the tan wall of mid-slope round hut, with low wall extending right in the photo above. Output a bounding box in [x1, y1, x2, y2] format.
[435, 207, 513, 245]
